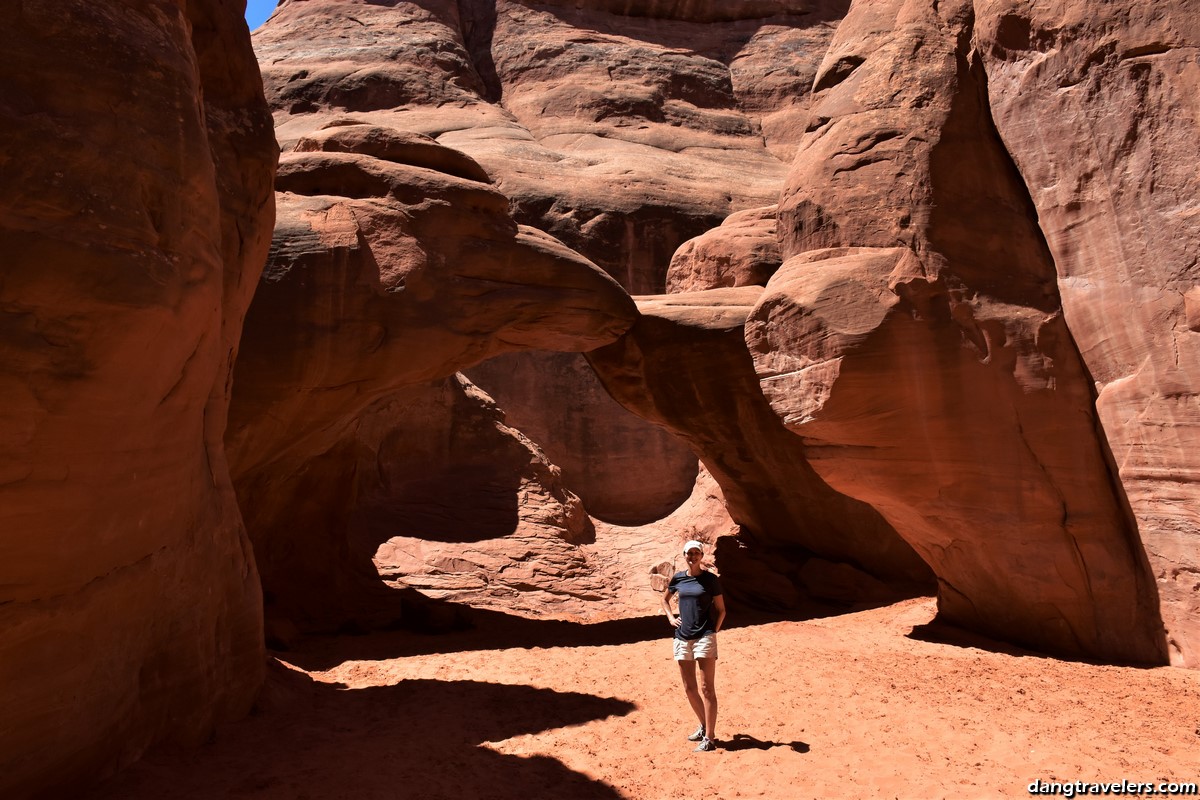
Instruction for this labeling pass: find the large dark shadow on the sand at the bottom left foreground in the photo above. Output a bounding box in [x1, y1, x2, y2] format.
[88, 664, 635, 800]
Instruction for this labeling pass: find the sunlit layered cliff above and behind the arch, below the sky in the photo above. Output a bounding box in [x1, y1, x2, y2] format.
[254, 0, 848, 293]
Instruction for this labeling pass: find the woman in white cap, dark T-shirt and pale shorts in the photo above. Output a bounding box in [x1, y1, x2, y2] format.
[662, 541, 725, 752]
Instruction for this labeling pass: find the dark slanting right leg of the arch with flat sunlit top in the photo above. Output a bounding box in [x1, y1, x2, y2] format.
[587, 287, 932, 608]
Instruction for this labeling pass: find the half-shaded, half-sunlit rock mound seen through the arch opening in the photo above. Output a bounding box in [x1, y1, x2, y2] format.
[350, 375, 611, 616]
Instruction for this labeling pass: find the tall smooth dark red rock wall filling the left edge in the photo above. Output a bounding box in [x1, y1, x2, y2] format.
[0, 0, 277, 796]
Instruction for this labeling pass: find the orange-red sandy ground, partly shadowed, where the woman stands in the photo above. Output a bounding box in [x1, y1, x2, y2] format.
[95, 599, 1200, 800]
